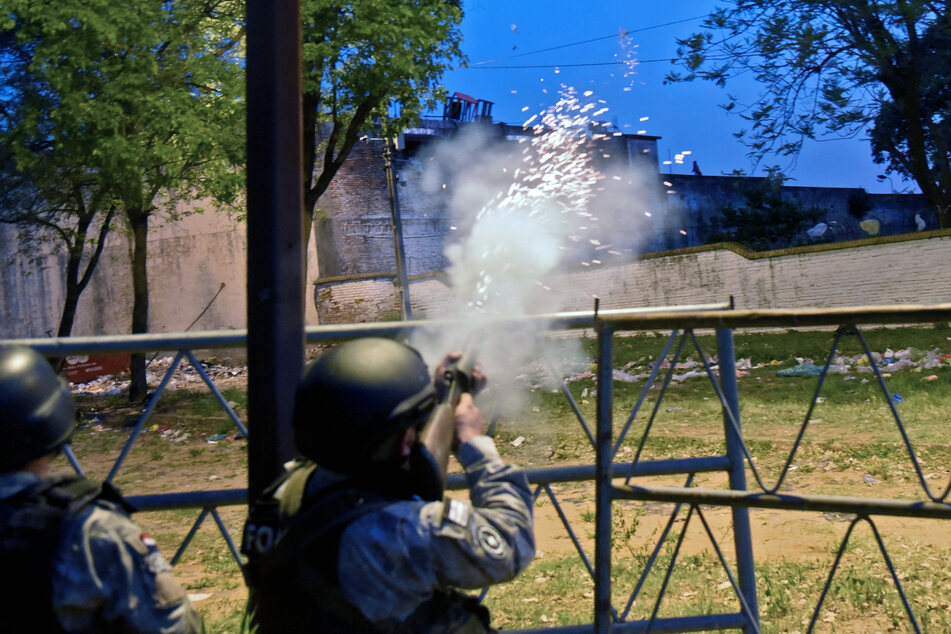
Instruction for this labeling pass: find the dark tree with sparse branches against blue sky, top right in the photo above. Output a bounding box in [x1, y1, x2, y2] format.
[668, 0, 951, 227]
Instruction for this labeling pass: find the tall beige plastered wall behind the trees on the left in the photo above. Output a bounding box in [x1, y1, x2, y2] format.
[0, 205, 317, 339]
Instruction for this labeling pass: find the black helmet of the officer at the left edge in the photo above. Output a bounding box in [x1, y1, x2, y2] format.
[0, 346, 76, 473]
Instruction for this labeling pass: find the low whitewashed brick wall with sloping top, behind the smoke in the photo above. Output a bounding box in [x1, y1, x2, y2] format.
[315, 231, 951, 323]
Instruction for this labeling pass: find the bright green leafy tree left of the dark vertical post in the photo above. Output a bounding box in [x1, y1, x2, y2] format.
[0, 0, 244, 400]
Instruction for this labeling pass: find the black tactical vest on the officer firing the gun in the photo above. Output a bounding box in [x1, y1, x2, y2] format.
[241, 463, 494, 634]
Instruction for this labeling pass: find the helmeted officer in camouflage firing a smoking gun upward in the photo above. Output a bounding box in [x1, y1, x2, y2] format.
[242, 338, 535, 633]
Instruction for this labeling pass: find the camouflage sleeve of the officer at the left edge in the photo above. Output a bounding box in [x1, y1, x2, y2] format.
[53, 506, 201, 634]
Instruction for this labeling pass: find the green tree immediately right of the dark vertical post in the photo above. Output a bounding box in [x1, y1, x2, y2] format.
[301, 0, 462, 235]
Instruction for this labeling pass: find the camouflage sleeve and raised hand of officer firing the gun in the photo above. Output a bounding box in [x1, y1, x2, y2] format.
[338, 436, 535, 621]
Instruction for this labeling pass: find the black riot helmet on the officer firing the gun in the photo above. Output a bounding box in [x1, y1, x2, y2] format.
[294, 337, 436, 473]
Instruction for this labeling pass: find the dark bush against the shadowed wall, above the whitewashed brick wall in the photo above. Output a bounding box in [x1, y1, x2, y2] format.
[707, 174, 825, 251]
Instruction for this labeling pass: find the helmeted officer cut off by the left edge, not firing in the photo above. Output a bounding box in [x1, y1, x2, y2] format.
[0, 346, 200, 633]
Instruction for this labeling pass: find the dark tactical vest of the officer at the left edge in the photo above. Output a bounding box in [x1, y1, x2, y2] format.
[0, 476, 118, 634]
